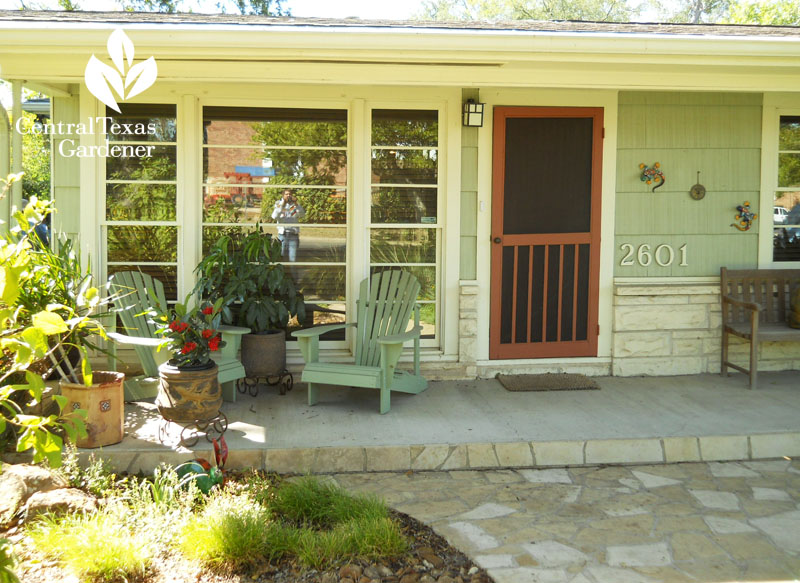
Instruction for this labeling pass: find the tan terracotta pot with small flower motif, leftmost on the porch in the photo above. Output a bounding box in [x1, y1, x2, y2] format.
[58, 371, 125, 447]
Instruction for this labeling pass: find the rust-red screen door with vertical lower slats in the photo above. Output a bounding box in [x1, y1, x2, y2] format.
[489, 107, 603, 359]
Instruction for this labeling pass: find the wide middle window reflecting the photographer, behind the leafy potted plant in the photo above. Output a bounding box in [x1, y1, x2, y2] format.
[203, 107, 348, 340]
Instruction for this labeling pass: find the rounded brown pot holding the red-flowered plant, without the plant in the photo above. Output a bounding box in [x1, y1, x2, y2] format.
[156, 361, 222, 423]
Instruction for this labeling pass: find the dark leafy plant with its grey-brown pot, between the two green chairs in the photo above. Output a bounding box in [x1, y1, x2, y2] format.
[195, 225, 305, 378]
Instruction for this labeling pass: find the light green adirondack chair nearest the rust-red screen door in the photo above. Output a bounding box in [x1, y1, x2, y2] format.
[293, 270, 428, 414]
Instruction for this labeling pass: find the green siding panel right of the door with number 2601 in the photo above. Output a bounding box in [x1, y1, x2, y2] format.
[614, 92, 769, 277]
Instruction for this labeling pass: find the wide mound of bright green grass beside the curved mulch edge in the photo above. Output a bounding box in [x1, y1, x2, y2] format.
[180, 477, 409, 572]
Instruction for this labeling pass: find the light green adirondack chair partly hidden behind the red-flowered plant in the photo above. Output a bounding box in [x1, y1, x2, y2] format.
[108, 271, 250, 401]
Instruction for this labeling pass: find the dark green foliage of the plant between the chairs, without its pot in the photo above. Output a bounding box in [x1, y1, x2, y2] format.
[194, 225, 305, 333]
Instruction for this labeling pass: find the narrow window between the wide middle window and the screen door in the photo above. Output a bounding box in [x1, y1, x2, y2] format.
[369, 109, 442, 339]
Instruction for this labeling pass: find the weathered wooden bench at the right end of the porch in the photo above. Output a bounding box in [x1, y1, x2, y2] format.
[720, 267, 800, 389]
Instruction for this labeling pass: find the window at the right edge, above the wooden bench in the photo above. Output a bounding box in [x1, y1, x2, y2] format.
[772, 115, 800, 261]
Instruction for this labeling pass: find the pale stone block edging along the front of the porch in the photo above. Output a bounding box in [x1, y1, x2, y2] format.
[57, 432, 800, 474]
